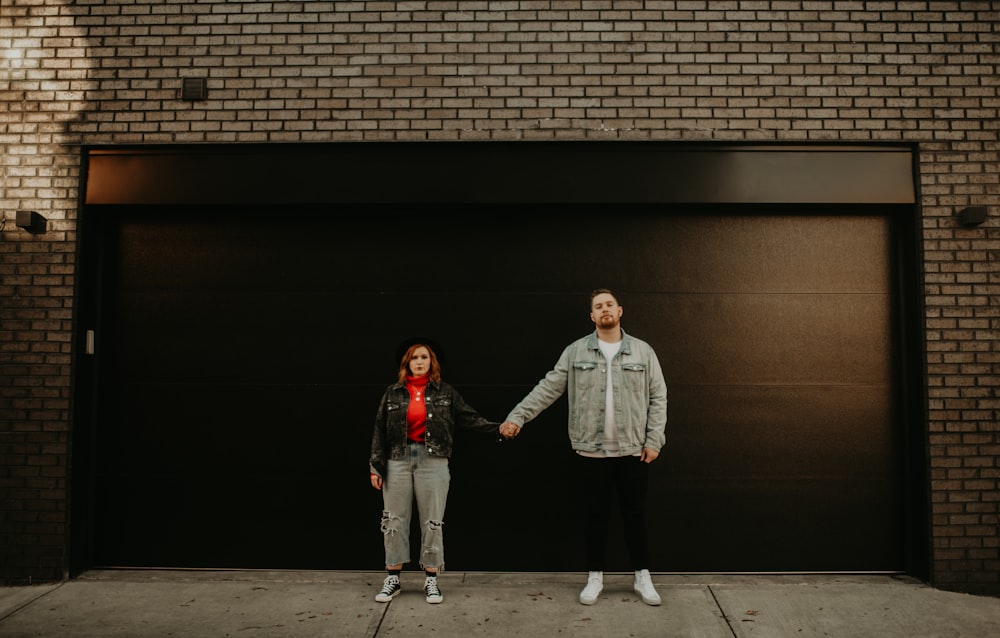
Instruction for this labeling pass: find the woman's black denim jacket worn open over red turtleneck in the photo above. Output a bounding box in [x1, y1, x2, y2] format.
[368, 381, 500, 477]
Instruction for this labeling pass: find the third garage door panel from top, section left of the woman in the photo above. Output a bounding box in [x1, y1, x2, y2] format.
[106, 383, 384, 483]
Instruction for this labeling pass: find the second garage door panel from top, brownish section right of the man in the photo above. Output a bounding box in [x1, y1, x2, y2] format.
[636, 293, 891, 385]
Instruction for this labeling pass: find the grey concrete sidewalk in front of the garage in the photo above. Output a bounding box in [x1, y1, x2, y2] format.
[0, 570, 1000, 638]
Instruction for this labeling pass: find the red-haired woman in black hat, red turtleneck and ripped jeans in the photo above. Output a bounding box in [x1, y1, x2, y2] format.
[369, 341, 500, 603]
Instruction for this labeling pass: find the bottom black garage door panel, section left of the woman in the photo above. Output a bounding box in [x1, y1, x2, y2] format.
[98, 470, 382, 569]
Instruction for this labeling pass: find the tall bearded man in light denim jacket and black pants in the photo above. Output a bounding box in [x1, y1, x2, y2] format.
[500, 288, 667, 605]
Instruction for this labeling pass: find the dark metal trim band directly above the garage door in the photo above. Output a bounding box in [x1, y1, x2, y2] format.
[85, 142, 915, 205]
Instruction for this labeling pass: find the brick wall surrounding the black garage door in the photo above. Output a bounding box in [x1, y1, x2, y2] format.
[0, 0, 1000, 594]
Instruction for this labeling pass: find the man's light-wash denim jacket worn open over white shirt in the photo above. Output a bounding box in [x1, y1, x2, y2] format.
[507, 330, 667, 456]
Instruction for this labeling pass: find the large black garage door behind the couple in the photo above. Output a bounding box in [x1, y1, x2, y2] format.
[76, 145, 918, 572]
